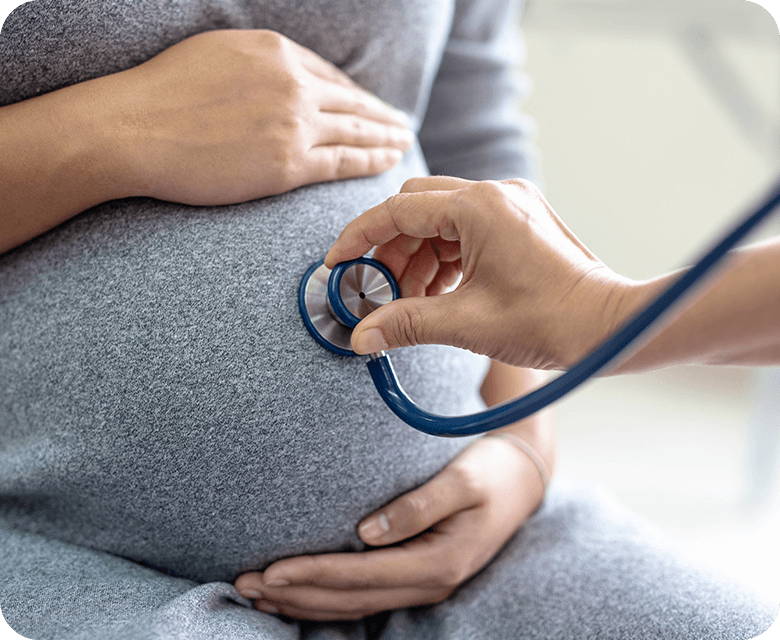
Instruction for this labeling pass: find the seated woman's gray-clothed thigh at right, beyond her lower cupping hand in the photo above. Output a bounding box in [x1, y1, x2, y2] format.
[381, 482, 777, 640]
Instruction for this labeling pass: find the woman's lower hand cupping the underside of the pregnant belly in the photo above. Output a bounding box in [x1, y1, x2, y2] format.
[236, 438, 543, 620]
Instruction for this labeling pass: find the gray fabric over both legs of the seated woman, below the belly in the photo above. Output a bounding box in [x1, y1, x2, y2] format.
[0, 481, 777, 640]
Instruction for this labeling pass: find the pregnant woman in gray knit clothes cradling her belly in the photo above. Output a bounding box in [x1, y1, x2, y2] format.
[0, 0, 776, 640]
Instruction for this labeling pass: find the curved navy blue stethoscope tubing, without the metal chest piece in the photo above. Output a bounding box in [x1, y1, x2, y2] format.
[368, 181, 780, 437]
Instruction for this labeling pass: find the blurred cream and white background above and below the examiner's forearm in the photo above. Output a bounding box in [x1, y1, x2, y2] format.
[521, 0, 780, 603]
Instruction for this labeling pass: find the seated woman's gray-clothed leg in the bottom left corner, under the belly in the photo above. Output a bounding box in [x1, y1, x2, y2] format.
[0, 524, 299, 640]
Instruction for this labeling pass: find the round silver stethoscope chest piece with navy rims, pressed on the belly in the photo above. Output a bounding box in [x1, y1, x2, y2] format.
[298, 258, 399, 356]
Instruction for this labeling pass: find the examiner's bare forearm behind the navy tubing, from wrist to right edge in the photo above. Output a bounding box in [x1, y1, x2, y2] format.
[612, 239, 780, 373]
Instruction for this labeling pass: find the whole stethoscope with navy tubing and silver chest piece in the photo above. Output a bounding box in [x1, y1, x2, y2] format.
[298, 182, 780, 436]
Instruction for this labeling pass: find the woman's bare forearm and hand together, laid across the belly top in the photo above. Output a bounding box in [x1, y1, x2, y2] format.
[0, 30, 414, 253]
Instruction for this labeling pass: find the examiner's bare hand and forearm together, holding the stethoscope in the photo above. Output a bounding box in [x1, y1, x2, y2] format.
[325, 177, 780, 374]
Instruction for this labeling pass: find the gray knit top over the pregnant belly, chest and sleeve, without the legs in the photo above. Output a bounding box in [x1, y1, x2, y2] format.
[0, 0, 526, 604]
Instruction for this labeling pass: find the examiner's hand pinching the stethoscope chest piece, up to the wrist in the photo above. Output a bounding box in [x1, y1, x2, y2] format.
[325, 177, 638, 369]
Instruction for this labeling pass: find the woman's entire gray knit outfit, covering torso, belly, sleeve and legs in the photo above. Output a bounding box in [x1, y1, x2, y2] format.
[0, 0, 776, 640]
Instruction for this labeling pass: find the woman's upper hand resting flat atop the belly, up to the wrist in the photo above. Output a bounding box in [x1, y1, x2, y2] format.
[111, 30, 413, 205]
